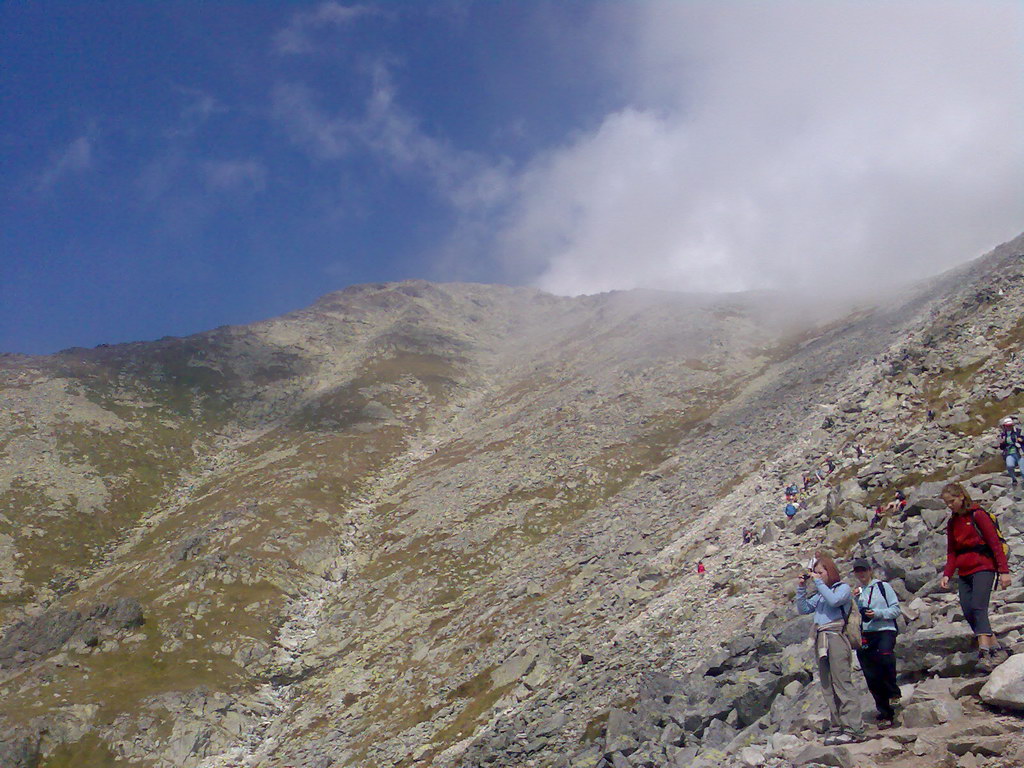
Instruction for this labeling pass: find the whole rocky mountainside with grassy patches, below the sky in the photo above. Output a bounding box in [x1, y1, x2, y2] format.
[0, 238, 1024, 768]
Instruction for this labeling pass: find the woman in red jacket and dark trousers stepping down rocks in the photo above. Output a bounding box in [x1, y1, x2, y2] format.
[939, 482, 1010, 669]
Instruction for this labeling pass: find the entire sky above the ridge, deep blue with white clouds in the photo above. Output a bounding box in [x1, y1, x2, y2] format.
[0, 0, 1024, 353]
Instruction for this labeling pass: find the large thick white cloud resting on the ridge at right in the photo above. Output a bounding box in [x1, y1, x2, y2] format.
[487, 2, 1024, 294]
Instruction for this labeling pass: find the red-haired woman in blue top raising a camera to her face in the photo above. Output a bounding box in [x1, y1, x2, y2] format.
[797, 553, 864, 744]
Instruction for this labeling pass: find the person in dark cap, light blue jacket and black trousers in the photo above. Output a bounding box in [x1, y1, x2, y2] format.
[853, 559, 900, 729]
